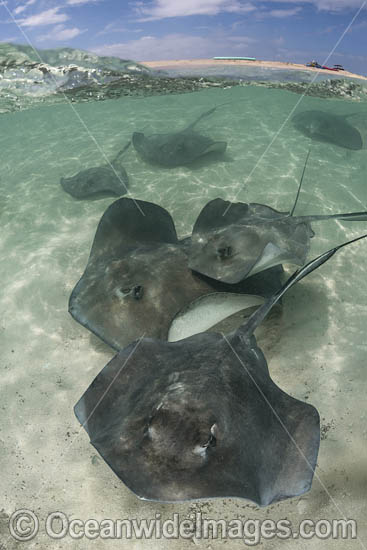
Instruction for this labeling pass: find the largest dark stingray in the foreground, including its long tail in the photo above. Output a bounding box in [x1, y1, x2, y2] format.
[75, 237, 363, 505]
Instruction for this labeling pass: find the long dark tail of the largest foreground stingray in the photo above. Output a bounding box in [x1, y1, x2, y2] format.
[237, 234, 367, 338]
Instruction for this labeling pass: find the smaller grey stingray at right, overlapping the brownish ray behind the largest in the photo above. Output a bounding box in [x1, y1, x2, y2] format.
[189, 153, 367, 284]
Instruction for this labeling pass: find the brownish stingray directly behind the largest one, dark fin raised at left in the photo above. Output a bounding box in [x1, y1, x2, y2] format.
[69, 198, 282, 349]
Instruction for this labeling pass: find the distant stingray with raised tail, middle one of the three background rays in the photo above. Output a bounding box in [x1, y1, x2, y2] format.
[132, 107, 227, 168]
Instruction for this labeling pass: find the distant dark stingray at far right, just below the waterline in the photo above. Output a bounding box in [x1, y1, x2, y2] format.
[292, 111, 363, 151]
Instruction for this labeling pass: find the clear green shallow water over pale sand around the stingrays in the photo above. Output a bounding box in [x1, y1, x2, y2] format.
[0, 45, 367, 550]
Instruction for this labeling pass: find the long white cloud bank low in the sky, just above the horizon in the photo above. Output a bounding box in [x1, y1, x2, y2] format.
[92, 33, 256, 61]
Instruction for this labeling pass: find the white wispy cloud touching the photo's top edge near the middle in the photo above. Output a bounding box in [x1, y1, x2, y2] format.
[134, 0, 256, 21]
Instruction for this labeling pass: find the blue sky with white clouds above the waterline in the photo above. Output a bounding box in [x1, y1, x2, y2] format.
[0, 0, 367, 75]
